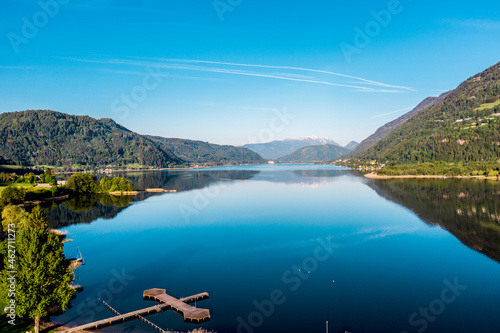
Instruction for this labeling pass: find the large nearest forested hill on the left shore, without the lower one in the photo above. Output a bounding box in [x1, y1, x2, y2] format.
[0, 110, 183, 167]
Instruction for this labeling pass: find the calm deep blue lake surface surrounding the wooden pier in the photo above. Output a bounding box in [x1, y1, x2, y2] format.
[52, 165, 500, 332]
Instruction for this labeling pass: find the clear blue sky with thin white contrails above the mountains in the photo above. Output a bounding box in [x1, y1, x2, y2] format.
[0, 0, 500, 145]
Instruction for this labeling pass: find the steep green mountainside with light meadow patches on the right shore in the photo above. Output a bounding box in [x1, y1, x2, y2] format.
[357, 63, 500, 163]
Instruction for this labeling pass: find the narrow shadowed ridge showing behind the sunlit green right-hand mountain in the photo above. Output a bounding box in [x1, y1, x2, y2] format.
[347, 91, 450, 157]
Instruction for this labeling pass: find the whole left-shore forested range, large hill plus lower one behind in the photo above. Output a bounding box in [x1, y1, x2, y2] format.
[0, 110, 265, 168]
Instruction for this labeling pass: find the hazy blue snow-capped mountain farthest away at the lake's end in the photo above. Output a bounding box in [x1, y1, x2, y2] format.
[243, 136, 340, 160]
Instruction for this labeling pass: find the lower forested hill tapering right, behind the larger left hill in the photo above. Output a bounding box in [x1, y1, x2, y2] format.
[146, 135, 265, 165]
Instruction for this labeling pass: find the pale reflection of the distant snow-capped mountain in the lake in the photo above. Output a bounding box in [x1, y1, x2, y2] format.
[252, 169, 346, 187]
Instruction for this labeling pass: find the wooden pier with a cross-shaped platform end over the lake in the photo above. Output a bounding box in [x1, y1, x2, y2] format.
[64, 288, 210, 333]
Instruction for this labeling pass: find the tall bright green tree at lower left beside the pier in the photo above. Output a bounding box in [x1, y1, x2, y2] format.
[1, 206, 73, 333]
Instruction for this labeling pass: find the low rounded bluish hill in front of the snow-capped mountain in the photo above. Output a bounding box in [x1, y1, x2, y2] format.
[278, 145, 350, 163]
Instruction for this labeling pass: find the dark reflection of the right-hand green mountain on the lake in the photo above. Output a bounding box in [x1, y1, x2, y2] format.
[368, 179, 500, 262]
